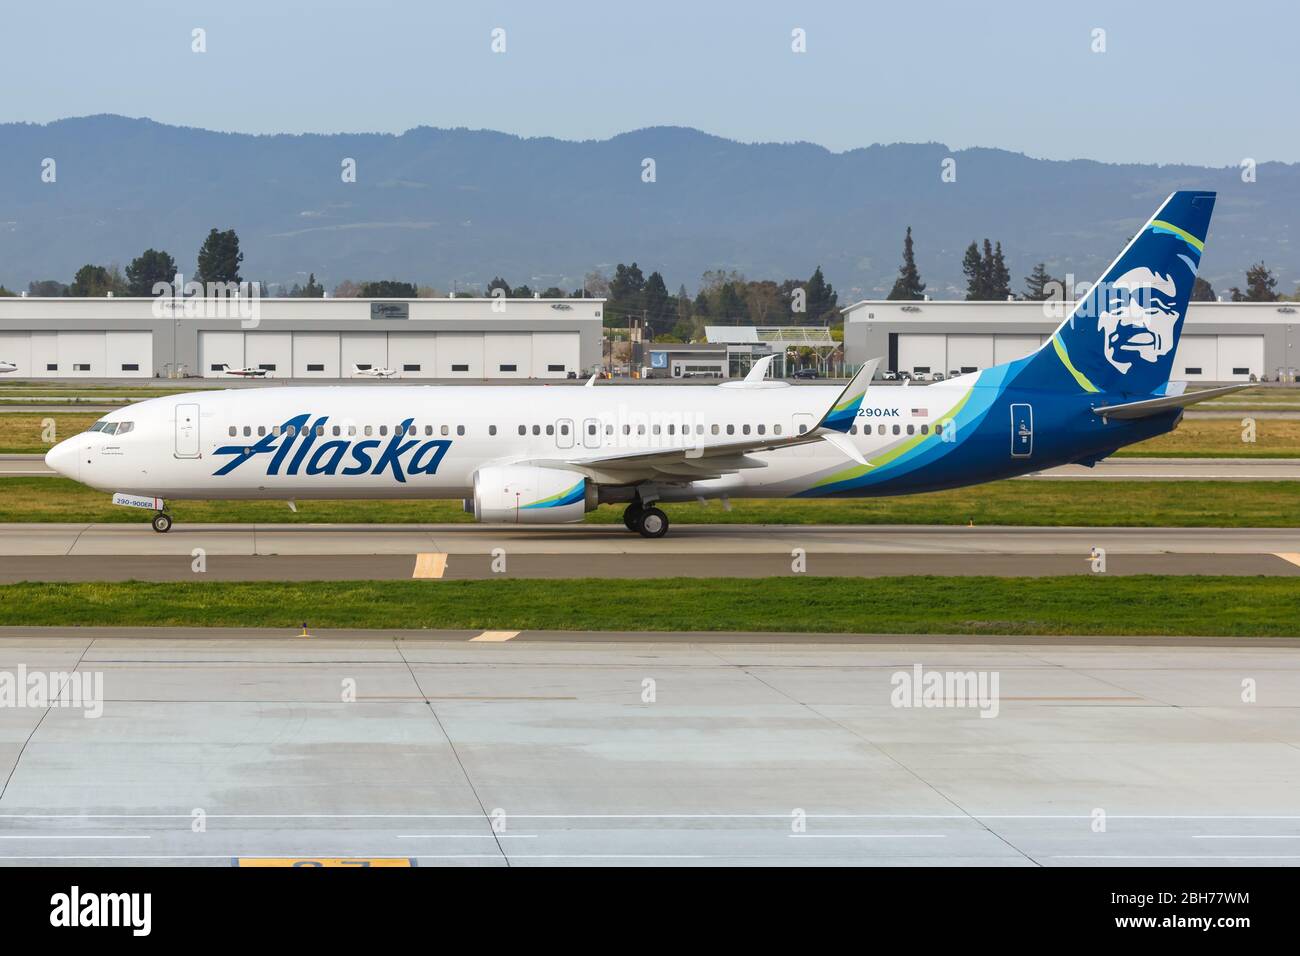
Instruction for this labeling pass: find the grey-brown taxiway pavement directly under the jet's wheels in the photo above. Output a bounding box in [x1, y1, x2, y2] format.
[0, 524, 1300, 583]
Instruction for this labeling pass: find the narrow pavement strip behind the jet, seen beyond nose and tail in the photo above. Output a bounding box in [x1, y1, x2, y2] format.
[0, 455, 1300, 481]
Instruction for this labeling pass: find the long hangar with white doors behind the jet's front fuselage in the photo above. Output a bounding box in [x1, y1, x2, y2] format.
[0, 297, 605, 378]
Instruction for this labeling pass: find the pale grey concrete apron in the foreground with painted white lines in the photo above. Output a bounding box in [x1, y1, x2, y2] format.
[0, 628, 1300, 866]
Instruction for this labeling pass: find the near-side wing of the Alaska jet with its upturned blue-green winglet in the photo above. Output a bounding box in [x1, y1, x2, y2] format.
[528, 359, 880, 485]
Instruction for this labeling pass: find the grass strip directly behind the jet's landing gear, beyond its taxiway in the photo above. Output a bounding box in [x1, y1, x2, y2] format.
[0, 477, 1300, 528]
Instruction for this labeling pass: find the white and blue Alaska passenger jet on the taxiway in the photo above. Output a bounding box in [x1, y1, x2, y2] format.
[46, 191, 1248, 538]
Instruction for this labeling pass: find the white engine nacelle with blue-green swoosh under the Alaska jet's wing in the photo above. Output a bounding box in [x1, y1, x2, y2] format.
[475, 464, 597, 524]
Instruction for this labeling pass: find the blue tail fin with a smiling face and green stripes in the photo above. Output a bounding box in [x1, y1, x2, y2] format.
[1030, 190, 1214, 394]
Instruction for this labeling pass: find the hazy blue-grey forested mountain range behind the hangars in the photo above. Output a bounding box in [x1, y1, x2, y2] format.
[0, 116, 1300, 303]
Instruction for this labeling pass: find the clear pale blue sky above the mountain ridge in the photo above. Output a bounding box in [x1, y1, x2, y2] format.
[0, 0, 1300, 166]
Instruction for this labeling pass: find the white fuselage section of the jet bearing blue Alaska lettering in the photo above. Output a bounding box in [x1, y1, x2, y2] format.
[47, 378, 971, 499]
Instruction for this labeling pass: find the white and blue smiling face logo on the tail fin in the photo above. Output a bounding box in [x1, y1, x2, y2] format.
[1097, 267, 1180, 375]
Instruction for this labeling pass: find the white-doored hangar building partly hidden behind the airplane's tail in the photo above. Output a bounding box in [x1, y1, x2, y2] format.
[844, 300, 1300, 382]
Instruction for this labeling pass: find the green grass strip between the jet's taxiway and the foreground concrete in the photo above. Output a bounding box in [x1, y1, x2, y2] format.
[0, 575, 1297, 637]
